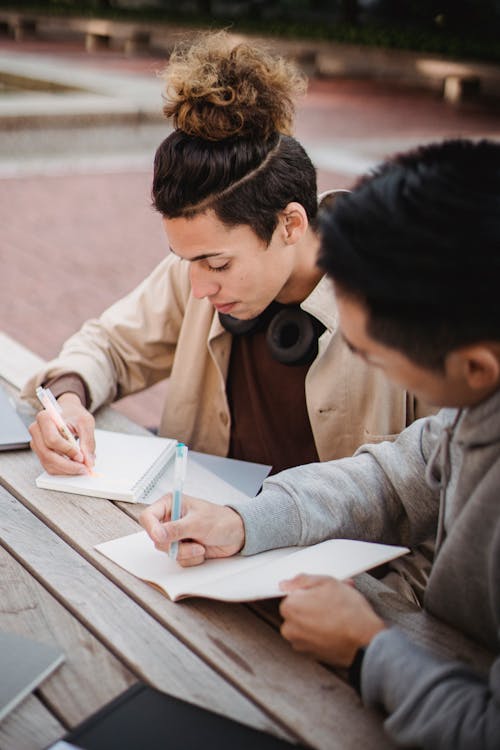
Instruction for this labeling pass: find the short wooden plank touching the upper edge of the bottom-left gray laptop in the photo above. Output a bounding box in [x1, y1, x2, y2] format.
[0, 547, 137, 727]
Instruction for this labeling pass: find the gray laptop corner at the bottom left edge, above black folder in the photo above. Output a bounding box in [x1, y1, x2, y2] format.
[0, 632, 64, 721]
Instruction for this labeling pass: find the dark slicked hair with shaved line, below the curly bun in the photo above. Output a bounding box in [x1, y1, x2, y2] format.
[152, 130, 317, 243]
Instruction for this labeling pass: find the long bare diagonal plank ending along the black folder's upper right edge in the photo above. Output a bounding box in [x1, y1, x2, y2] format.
[0, 488, 290, 744]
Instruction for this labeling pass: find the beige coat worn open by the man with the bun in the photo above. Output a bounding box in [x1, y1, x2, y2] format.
[23, 255, 425, 461]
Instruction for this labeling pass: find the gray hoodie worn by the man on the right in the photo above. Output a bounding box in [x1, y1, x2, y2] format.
[232, 391, 500, 750]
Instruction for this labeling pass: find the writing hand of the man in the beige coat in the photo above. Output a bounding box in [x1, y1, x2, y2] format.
[28, 393, 95, 474]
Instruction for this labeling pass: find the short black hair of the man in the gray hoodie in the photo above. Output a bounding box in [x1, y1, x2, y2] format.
[318, 139, 500, 370]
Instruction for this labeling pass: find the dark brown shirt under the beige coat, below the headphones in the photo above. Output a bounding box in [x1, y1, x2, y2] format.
[227, 330, 318, 474]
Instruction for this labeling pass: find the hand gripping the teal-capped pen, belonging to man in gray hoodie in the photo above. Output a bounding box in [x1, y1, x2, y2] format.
[139, 494, 245, 567]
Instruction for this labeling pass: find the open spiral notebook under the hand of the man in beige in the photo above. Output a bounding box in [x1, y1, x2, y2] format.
[36, 430, 270, 503]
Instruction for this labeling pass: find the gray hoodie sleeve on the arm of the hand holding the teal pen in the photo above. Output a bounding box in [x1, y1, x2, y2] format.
[230, 411, 454, 555]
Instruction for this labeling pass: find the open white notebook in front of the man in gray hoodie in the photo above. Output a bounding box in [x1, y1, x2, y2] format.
[96, 531, 409, 602]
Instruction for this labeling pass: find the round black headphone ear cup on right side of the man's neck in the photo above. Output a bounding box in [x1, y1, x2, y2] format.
[266, 307, 318, 365]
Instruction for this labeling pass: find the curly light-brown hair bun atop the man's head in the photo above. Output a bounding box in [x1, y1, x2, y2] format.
[163, 31, 306, 141]
